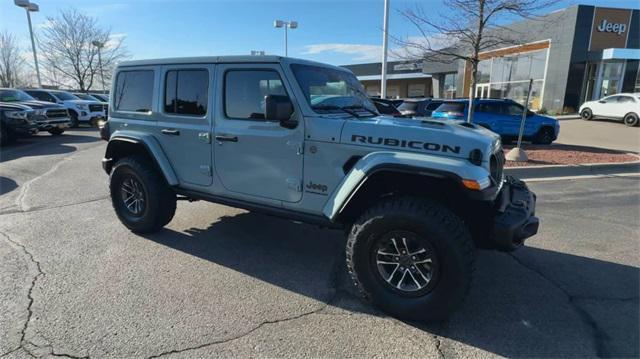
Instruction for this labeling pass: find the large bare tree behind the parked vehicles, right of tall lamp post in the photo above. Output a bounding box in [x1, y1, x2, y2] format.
[39, 9, 127, 91]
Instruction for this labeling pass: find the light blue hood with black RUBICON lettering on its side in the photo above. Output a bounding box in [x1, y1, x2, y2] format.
[340, 116, 500, 159]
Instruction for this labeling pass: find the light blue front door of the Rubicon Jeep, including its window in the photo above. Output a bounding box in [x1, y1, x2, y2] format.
[213, 64, 304, 202]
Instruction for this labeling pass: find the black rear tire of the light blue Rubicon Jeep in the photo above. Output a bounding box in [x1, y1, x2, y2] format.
[109, 156, 176, 233]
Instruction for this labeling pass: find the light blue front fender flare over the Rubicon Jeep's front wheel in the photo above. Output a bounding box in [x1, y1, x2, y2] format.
[322, 151, 489, 221]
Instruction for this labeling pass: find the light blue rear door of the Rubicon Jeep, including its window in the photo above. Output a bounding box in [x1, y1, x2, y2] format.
[156, 65, 215, 187]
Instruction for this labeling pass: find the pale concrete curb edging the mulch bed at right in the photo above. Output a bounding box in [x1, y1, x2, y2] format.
[504, 161, 640, 180]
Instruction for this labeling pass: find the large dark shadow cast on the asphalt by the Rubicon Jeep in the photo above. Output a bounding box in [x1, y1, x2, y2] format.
[146, 213, 640, 357]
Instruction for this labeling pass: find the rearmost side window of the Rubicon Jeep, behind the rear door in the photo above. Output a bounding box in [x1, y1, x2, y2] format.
[113, 70, 153, 112]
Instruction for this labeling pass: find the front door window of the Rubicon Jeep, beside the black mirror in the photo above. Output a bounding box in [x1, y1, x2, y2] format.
[224, 70, 287, 120]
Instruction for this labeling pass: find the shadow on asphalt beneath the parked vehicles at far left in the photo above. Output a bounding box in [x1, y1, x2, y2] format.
[0, 128, 100, 163]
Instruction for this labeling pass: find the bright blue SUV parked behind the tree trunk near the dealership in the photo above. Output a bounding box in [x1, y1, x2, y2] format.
[431, 99, 560, 145]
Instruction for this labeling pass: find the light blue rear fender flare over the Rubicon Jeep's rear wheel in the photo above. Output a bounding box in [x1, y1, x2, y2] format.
[105, 130, 179, 186]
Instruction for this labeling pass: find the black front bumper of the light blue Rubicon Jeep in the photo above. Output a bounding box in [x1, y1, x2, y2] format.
[492, 176, 540, 252]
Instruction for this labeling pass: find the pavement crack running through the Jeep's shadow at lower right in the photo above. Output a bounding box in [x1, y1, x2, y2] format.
[507, 253, 612, 358]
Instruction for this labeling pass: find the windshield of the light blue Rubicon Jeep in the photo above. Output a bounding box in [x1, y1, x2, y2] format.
[291, 64, 376, 115]
